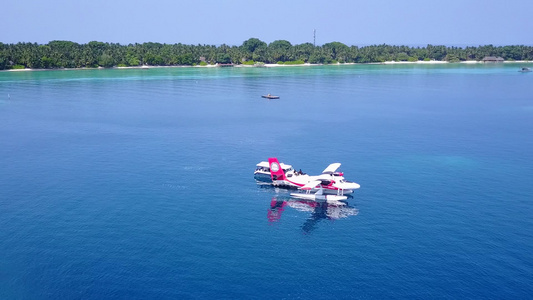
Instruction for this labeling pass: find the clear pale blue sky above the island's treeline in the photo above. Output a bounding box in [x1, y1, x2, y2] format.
[4, 0, 533, 46]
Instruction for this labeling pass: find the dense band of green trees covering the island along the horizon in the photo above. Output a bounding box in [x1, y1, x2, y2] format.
[0, 38, 533, 70]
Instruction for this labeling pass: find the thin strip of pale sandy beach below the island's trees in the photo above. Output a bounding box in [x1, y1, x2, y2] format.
[0, 60, 533, 72]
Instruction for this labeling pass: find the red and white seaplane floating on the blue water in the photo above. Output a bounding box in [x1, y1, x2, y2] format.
[254, 157, 360, 198]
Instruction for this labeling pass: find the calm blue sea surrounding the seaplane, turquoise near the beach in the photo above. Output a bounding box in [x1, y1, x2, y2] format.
[0, 64, 533, 299]
